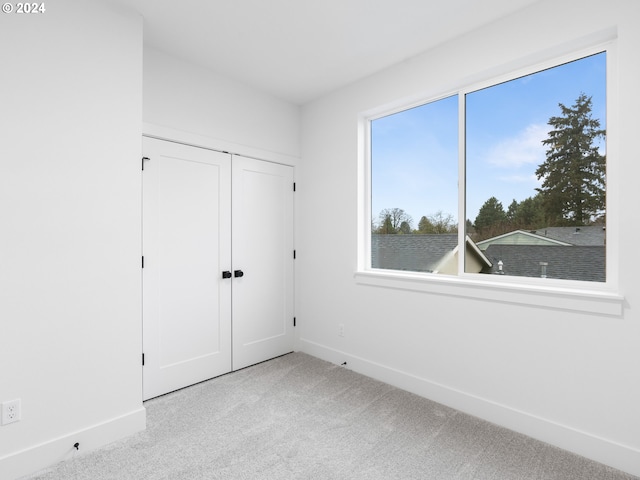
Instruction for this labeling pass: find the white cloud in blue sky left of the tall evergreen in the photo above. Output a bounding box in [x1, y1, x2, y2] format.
[486, 124, 549, 168]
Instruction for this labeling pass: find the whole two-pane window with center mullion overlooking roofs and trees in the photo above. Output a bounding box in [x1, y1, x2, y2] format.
[367, 51, 607, 282]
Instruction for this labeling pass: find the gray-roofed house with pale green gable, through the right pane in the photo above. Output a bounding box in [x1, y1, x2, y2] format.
[477, 226, 606, 282]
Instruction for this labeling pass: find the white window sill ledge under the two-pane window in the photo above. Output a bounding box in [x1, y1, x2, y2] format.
[354, 270, 624, 317]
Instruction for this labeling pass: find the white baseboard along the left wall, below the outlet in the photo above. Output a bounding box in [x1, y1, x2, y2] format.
[0, 407, 147, 480]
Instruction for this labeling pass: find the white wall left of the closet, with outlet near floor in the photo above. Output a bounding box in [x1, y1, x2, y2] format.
[0, 0, 145, 479]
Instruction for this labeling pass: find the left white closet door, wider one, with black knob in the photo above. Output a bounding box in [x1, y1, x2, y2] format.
[142, 138, 232, 399]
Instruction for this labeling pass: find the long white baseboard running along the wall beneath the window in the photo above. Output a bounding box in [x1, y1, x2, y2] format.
[297, 338, 640, 476]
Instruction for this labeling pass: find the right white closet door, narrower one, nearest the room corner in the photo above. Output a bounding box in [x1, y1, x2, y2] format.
[232, 156, 294, 370]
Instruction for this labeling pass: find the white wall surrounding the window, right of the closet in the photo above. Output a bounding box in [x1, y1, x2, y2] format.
[297, 0, 640, 474]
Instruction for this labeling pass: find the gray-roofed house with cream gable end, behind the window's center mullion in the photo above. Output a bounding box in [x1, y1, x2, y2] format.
[371, 233, 492, 275]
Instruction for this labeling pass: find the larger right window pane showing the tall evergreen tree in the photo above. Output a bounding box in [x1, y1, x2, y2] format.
[465, 52, 606, 282]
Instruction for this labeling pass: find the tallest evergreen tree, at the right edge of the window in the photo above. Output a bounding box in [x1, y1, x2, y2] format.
[536, 93, 606, 225]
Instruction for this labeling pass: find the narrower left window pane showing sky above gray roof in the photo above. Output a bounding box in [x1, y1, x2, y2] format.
[371, 96, 458, 274]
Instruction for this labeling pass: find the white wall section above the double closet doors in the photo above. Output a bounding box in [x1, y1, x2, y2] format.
[143, 46, 300, 165]
